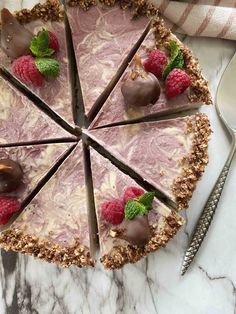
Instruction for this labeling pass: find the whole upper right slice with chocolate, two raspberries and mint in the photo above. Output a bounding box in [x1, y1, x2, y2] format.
[90, 19, 211, 128]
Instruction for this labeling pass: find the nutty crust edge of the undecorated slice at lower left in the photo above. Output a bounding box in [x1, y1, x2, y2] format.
[0, 229, 95, 267]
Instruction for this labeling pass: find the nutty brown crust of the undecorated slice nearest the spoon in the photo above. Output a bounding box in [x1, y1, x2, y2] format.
[173, 113, 211, 210]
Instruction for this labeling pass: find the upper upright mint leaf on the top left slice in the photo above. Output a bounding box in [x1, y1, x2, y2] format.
[30, 29, 55, 57]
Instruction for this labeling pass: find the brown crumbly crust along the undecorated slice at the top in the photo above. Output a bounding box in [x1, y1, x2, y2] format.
[67, 0, 158, 17]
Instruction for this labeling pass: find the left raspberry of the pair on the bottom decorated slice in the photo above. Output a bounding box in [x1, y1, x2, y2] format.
[101, 199, 125, 225]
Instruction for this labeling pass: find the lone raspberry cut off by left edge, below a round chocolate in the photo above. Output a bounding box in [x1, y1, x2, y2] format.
[0, 196, 20, 225]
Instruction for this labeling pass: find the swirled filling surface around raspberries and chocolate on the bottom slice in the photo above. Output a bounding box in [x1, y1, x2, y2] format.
[90, 148, 180, 255]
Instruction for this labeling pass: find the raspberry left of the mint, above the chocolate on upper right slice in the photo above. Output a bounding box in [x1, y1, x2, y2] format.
[143, 49, 168, 77]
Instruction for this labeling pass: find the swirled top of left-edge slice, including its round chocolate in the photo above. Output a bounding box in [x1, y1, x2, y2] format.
[0, 143, 75, 202]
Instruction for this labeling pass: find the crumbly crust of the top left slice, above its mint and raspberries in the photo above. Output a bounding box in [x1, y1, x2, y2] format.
[11, 0, 64, 24]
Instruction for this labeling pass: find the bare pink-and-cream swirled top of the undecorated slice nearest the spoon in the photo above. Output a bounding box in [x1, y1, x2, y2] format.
[88, 116, 195, 201]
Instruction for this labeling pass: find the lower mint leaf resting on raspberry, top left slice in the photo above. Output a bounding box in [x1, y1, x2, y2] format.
[35, 58, 60, 77]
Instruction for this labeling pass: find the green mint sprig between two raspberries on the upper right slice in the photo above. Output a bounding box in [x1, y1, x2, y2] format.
[162, 41, 184, 79]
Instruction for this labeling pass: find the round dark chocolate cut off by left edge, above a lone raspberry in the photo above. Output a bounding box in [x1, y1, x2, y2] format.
[0, 158, 23, 193]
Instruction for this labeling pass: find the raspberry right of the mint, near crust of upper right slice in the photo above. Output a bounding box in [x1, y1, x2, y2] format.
[165, 69, 191, 98]
